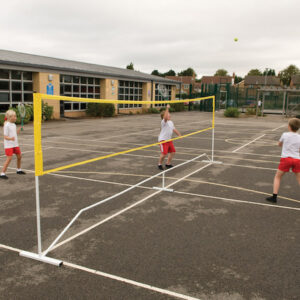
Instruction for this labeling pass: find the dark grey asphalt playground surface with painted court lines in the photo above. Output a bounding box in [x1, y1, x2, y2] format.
[0, 112, 300, 300]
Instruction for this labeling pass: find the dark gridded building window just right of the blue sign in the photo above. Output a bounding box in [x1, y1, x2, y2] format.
[60, 75, 100, 111]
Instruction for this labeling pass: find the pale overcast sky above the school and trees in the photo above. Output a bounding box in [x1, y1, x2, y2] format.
[0, 0, 300, 78]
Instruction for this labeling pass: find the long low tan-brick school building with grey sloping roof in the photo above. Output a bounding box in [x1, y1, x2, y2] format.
[0, 50, 178, 119]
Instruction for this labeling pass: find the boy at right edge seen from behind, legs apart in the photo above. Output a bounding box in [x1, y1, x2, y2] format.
[266, 118, 300, 203]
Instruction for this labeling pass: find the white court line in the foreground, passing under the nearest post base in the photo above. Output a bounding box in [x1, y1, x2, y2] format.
[0, 244, 200, 300]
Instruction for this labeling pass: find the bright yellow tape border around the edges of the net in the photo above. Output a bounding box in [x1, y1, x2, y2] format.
[33, 93, 215, 176]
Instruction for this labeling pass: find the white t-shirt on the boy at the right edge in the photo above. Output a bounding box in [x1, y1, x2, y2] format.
[279, 132, 300, 159]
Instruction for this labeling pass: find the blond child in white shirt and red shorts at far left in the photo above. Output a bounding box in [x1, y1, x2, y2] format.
[0, 110, 25, 179]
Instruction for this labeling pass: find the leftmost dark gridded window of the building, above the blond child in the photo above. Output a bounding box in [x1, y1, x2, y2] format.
[0, 69, 33, 112]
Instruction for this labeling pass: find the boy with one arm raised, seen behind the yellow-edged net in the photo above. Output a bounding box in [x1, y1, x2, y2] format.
[158, 104, 181, 170]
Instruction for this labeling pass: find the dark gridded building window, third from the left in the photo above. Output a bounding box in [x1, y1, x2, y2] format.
[118, 80, 143, 109]
